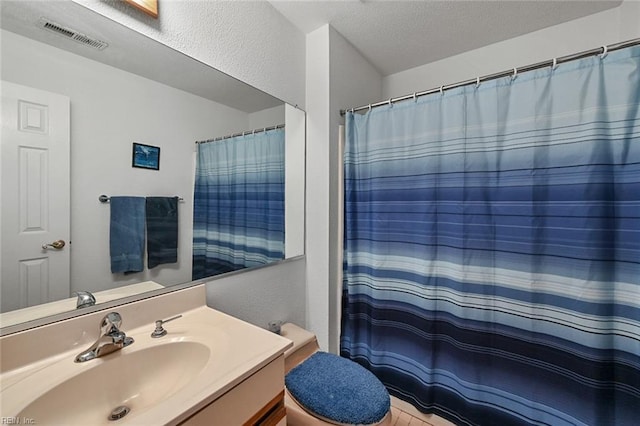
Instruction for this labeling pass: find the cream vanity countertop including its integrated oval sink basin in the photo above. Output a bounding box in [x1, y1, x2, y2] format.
[0, 299, 292, 426]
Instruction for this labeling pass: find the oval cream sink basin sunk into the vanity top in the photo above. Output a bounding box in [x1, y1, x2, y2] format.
[18, 342, 210, 425]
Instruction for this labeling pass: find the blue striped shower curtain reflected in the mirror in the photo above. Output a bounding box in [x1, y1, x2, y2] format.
[193, 129, 284, 280]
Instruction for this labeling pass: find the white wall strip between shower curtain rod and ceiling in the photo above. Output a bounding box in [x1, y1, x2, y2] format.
[378, 0, 640, 101]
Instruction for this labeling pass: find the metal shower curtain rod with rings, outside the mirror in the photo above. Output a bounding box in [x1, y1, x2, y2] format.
[340, 38, 640, 116]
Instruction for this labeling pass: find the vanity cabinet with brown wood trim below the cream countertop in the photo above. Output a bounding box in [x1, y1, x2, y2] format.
[181, 355, 287, 426]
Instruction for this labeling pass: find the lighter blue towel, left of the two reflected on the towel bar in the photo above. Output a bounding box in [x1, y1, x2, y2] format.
[109, 197, 145, 274]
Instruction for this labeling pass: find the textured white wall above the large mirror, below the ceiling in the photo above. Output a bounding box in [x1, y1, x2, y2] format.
[74, 0, 305, 109]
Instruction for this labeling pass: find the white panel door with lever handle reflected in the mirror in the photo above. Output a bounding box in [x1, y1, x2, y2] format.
[0, 81, 71, 312]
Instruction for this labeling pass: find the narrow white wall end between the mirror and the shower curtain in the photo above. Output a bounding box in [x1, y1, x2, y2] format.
[306, 25, 382, 352]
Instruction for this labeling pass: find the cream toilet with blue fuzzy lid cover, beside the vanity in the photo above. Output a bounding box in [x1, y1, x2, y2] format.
[280, 323, 392, 426]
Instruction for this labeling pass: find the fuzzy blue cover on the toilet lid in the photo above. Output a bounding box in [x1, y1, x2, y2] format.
[285, 352, 391, 425]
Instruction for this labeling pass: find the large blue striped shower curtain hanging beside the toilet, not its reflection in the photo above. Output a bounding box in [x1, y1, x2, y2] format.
[341, 47, 640, 426]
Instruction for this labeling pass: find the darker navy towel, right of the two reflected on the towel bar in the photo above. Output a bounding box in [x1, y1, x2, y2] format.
[146, 197, 178, 269]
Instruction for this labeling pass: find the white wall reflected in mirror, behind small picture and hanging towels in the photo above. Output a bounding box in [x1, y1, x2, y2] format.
[2, 30, 249, 292]
